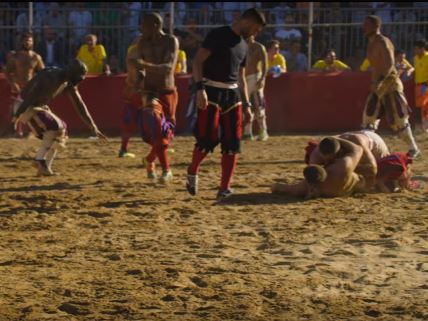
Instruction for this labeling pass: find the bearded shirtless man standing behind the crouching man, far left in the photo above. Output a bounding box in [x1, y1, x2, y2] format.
[6, 32, 45, 137]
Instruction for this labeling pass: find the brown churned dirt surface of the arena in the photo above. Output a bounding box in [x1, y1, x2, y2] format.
[0, 134, 428, 321]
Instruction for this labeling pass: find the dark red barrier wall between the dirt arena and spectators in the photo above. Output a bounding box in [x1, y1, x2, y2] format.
[0, 72, 414, 135]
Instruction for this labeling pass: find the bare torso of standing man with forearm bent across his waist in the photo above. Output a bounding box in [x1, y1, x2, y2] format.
[137, 34, 178, 91]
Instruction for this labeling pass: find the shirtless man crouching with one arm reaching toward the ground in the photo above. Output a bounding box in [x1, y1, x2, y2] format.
[13, 59, 106, 176]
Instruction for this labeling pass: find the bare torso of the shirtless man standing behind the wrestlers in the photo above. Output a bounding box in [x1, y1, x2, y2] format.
[367, 34, 396, 81]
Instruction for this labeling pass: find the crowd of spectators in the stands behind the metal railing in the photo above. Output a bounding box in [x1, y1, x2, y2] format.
[0, 2, 428, 73]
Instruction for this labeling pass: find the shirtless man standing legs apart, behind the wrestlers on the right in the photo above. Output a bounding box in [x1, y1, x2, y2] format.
[362, 15, 420, 158]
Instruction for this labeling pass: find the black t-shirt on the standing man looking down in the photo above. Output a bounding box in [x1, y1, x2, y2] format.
[202, 26, 248, 83]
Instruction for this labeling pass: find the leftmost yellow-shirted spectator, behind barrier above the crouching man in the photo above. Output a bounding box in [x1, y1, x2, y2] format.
[77, 34, 111, 75]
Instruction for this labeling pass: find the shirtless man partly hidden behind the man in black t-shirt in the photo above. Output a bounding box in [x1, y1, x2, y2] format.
[243, 36, 269, 141]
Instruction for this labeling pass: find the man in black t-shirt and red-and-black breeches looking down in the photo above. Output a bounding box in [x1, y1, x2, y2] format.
[186, 8, 266, 199]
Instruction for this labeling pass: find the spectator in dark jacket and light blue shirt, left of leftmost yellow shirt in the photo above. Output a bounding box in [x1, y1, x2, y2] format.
[37, 26, 65, 67]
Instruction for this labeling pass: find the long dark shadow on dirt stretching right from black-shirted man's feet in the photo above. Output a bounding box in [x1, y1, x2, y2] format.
[215, 193, 305, 205]
